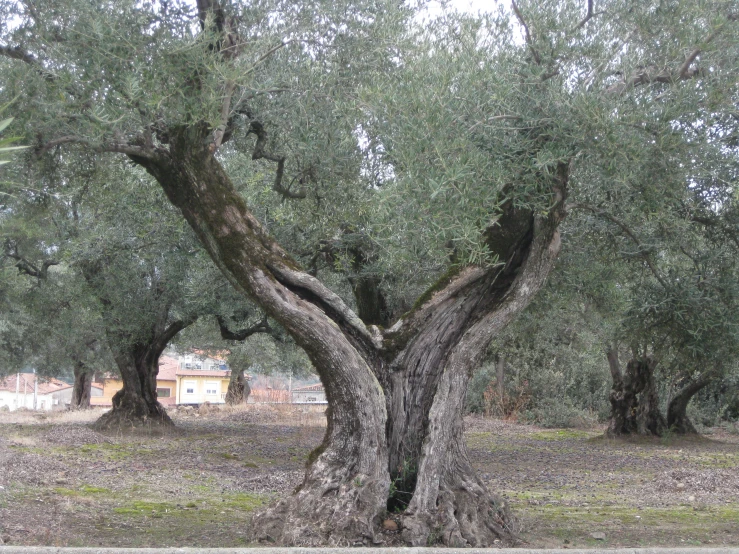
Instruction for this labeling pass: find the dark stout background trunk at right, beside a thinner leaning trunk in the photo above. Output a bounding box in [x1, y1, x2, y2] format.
[606, 354, 667, 437]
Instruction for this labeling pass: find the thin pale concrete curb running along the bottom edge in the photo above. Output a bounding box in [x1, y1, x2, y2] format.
[0, 545, 739, 554]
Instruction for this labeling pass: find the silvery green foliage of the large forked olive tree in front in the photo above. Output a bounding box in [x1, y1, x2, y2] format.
[0, 0, 739, 388]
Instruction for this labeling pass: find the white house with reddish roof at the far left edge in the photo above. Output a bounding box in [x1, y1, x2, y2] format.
[0, 373, 72, 411]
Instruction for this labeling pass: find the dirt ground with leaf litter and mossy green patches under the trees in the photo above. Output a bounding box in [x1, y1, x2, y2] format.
[0, 406, 739, 548]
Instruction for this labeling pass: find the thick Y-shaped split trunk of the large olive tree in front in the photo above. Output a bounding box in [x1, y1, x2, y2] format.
[131, 125, 567, 547]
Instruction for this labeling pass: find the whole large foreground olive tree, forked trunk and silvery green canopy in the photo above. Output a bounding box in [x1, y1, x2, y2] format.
[0, 0, 739, 546]
